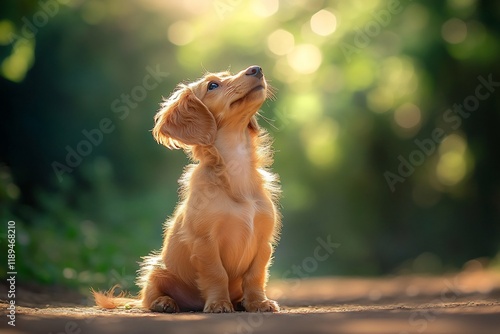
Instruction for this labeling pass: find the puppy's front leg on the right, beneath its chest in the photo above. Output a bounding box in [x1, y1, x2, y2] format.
[242, 242, 280, 312]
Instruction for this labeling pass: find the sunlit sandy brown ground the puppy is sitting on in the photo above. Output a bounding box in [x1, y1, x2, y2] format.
[0, 268, 500, 334]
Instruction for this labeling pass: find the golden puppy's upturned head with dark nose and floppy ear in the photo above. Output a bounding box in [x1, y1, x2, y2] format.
[153, 66, 268, 148]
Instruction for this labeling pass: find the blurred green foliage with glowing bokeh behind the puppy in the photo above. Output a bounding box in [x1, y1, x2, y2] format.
[0, 0, 500, 288]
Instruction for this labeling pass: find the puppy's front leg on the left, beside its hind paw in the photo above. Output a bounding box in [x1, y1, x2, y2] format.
[191, 238, 234, 313]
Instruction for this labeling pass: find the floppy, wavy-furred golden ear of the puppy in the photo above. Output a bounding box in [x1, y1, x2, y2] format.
[153, 86, 217, 149]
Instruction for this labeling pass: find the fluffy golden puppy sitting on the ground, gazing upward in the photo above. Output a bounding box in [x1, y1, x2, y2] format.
[94, 66, 280, 313]
